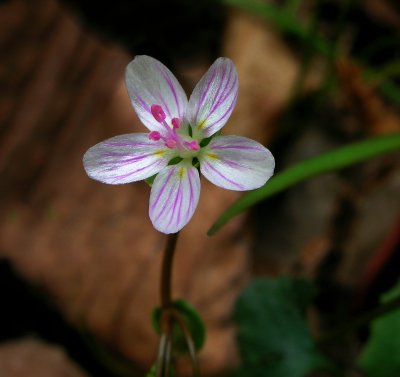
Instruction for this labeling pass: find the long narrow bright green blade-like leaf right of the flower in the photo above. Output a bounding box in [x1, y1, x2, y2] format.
[208, 133, 400, 232]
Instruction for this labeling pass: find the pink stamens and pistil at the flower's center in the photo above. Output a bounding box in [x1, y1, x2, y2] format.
[149, 104, 200, 157]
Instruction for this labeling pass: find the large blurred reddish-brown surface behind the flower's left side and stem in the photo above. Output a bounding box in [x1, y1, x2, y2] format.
[0, 0, 292, 372]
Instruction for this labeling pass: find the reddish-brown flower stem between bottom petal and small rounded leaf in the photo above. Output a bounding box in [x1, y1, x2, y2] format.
[160, 232, 179, 309]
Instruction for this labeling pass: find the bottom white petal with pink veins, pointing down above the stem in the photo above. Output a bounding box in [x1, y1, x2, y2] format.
[149, 164, 200, 234]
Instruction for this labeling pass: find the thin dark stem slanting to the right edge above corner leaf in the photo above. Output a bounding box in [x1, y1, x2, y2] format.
[317, 297, 400, 344]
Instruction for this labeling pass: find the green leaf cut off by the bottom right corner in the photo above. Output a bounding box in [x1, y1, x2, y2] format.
[358, 283, 400, 377]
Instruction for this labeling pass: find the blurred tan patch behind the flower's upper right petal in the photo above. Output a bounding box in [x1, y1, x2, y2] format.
[223, 9, 298, 141]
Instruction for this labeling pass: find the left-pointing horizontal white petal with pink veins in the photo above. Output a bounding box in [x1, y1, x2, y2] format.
[83, 133, 173, 185]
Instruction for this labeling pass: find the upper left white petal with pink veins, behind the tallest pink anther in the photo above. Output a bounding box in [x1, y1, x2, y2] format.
[125, 55, 188, 132]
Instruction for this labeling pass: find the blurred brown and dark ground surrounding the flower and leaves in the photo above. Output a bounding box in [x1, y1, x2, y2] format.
[0, 0, 400, 377]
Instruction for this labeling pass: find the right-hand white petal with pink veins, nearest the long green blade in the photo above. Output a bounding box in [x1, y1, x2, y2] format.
[200, 136, 275, 191]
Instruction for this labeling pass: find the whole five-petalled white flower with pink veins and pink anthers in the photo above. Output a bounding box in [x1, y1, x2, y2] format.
[83, 56, 275, 234]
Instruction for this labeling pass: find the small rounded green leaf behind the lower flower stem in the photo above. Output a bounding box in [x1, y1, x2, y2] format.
[151, 300, 206, 353]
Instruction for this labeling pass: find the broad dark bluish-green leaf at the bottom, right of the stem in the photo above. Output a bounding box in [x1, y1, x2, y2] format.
[234, 278, 329, 377]
